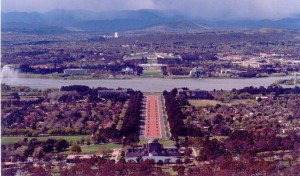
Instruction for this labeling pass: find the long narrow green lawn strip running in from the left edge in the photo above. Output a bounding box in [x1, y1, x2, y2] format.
[1, 135, 90, 144]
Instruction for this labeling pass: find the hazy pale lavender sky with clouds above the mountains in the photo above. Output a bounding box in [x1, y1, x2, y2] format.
[1, 0, 300, 19]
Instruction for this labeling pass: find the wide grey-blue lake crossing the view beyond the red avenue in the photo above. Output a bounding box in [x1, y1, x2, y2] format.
[1, 76, 292, 92]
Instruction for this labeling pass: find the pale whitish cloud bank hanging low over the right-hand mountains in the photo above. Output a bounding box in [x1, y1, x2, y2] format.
[156, 0, 300, 19]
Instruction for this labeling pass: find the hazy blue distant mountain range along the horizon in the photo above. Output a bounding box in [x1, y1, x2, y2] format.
[1, 10, 300, 33]
